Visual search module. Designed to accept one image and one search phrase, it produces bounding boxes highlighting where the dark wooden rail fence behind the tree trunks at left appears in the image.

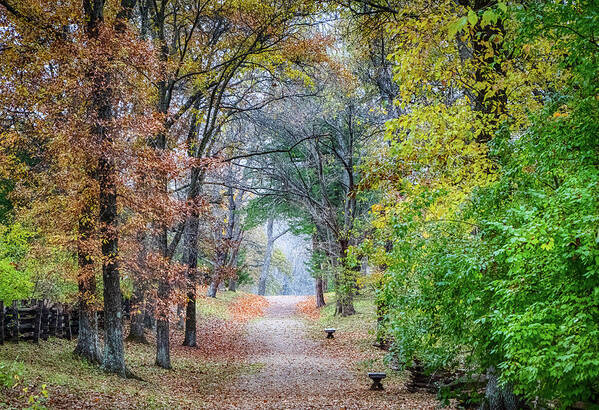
[0,299,130,345]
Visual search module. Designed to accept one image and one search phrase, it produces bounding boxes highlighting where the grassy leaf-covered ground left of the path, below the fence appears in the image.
[0,292,268,408]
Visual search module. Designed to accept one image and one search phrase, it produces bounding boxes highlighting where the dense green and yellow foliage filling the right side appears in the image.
[363,2,599,407]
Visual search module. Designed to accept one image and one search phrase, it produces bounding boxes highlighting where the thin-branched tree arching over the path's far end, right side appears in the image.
[234,65,380,315]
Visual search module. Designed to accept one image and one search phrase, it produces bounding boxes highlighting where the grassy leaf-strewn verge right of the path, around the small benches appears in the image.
[305,293,407,384]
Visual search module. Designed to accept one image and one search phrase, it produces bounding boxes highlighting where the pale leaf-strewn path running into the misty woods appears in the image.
[213,296,435,409]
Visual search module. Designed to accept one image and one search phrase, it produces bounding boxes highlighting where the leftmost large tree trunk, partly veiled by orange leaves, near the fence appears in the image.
[74,203,101,363]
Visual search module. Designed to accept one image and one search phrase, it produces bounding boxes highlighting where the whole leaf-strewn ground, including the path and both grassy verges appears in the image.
[0,292,446,409]
